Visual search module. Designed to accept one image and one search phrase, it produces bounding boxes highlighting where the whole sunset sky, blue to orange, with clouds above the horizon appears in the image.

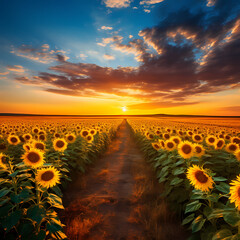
[0,0,240,116]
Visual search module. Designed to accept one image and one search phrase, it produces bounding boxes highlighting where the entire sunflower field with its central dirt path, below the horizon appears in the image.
[0,116,240,240]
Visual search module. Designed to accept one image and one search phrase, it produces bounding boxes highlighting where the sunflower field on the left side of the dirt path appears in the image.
[0,118,121,240]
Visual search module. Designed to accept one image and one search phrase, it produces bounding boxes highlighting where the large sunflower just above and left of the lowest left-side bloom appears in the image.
[22,148,44,168]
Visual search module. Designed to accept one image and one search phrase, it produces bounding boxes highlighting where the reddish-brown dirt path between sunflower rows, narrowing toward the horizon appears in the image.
[61,120,188,240]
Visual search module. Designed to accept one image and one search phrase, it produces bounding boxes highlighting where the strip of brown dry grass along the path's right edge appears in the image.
[129,158,187,240]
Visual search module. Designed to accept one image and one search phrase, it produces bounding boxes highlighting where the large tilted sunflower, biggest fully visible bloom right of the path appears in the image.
[187,165,214,192]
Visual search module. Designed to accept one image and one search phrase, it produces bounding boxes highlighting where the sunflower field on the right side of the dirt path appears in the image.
[129,119,240,240]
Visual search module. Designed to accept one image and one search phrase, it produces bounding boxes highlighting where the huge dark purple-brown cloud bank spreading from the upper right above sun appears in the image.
[14,0,240,108]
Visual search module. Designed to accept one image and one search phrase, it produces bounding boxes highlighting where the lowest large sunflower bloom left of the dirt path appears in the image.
[36,167,60,188]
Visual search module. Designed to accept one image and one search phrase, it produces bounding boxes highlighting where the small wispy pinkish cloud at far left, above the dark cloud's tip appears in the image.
[11,44,69,64]
